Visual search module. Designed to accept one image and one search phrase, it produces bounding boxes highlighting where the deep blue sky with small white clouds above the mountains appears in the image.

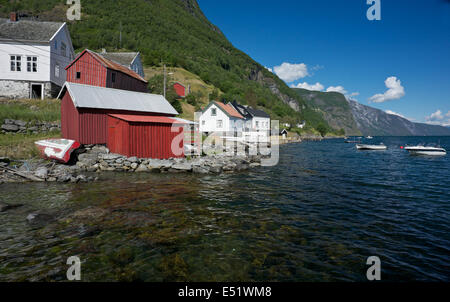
[198,0,450,125]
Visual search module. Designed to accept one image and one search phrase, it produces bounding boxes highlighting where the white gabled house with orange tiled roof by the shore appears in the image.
[199,102,244,134]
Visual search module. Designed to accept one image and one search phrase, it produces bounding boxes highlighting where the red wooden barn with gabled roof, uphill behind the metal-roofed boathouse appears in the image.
[65,49,148,92]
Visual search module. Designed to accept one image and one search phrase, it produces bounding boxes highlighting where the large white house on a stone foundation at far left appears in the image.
[0,13,74,99]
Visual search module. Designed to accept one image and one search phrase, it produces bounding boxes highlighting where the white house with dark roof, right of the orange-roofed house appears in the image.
[231,101,270,142]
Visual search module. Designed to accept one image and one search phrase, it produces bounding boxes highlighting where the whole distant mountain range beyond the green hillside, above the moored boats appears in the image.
[292,88,450,136]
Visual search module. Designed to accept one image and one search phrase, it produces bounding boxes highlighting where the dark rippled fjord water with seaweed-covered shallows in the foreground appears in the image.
[0,137,450,281]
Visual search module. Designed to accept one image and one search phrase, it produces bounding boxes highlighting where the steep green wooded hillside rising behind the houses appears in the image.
[0,0,326,131]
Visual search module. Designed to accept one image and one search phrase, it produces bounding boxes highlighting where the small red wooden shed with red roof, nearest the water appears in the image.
[107,114,184,159]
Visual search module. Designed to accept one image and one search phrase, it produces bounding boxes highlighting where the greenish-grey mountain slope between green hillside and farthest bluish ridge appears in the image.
[293,88,361,135]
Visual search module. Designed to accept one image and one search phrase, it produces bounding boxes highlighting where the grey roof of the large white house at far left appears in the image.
[0,18,64,42]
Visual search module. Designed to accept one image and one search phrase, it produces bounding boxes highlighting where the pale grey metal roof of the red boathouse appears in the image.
[58,82,178,115]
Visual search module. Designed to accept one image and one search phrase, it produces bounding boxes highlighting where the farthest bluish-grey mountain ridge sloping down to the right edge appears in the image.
[349,101,450,136]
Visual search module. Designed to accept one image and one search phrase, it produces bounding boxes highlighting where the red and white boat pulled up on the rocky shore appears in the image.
[35,138,81,163]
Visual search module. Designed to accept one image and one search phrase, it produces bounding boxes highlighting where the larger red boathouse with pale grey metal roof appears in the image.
[58,82,178,145]
